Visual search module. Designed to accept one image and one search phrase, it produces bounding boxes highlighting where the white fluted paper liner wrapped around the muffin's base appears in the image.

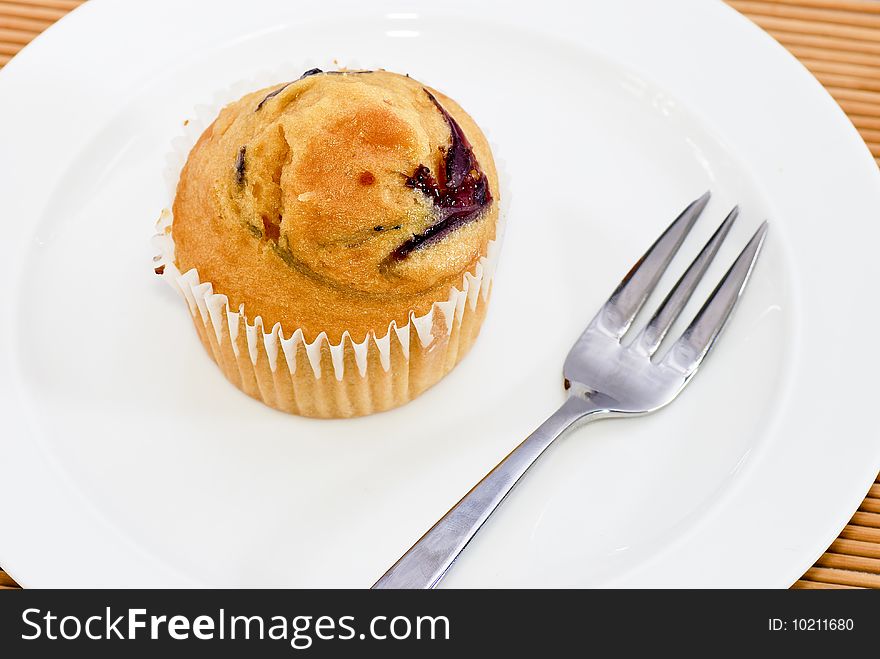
[153,65,502,418]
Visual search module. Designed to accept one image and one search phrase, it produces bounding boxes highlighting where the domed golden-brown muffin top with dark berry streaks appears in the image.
[172,69,499,342]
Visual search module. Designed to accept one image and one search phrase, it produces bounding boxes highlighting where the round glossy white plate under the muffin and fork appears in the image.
[0,0,880,587]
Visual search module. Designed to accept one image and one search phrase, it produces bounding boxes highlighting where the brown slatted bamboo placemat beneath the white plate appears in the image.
[0,0,880,590]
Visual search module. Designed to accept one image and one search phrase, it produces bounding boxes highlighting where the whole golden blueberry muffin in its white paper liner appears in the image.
[157,69,500,417]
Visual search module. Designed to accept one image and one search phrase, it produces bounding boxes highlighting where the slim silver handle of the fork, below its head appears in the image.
[373,395,602,588]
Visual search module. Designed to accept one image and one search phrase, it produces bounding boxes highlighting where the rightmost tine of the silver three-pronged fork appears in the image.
[663,222,768,375]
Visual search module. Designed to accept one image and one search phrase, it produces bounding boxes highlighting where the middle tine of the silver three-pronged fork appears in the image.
[633,206,739,355]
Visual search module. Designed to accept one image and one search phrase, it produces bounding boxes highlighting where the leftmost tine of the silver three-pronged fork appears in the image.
[593,191,710,338]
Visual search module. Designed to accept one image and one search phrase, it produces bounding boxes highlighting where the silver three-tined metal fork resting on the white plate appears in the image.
[373,192,768,588]
